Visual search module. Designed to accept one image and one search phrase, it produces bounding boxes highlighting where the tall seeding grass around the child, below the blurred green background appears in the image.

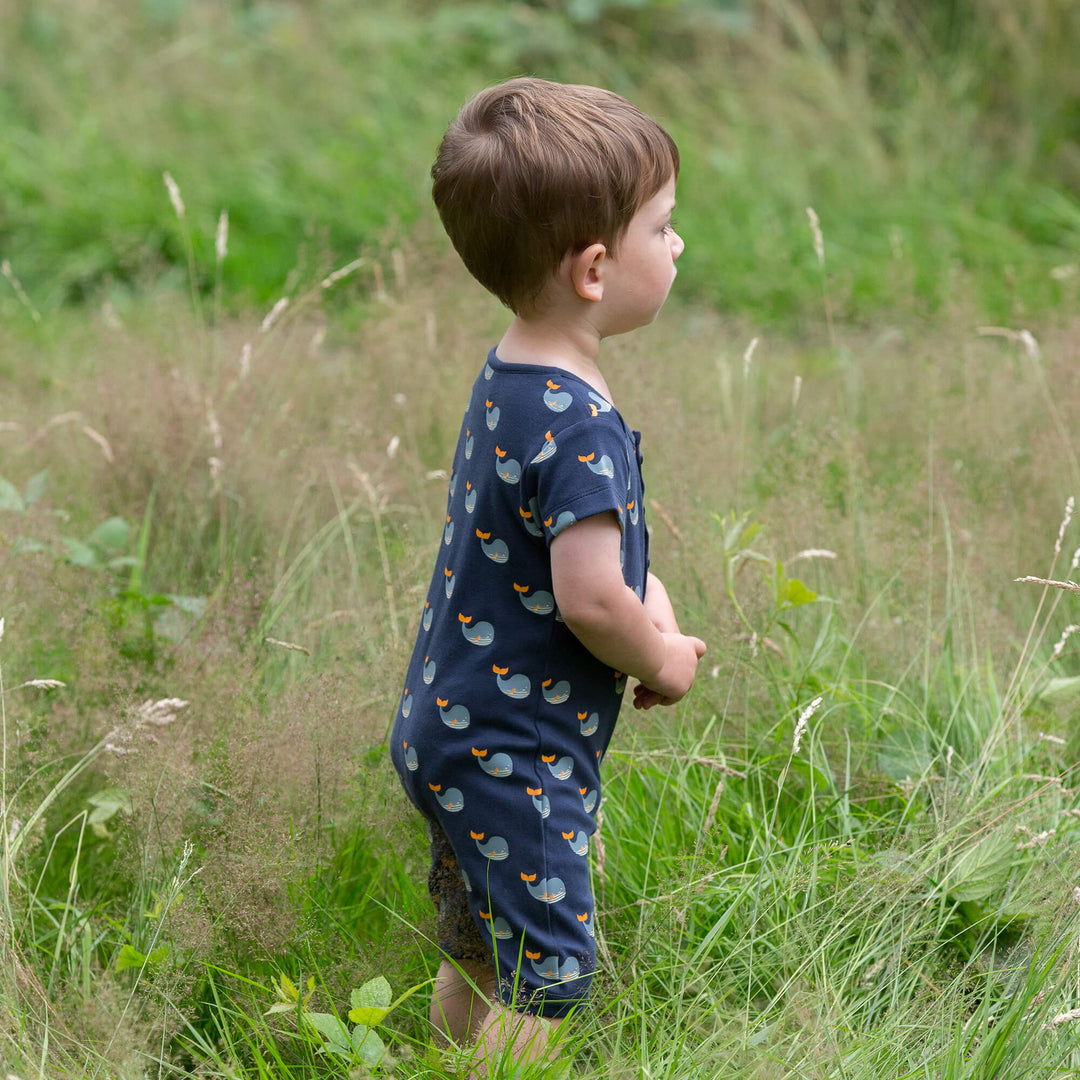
[0,192,1080,1078]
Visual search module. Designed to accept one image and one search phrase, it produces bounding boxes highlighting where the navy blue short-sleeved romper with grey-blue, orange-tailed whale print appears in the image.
[391,349,648,1017]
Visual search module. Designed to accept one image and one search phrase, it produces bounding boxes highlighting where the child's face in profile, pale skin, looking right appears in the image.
[603,177,684,334]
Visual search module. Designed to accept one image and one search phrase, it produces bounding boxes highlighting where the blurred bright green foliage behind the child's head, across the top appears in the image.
[0,0,1080,320]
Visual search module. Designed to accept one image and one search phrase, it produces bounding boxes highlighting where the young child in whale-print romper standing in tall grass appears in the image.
[391,79,705,1071]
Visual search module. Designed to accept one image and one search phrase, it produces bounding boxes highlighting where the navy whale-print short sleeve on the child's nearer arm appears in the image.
[523,414,635,543]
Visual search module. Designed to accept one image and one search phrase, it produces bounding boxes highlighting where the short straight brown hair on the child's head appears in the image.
[431,79,678,312]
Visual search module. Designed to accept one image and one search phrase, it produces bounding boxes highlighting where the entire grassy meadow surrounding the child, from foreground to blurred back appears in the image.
[0,0,1080,1080]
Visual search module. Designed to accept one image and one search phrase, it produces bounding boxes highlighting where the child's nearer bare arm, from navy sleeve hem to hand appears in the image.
[551,513,705,702]
